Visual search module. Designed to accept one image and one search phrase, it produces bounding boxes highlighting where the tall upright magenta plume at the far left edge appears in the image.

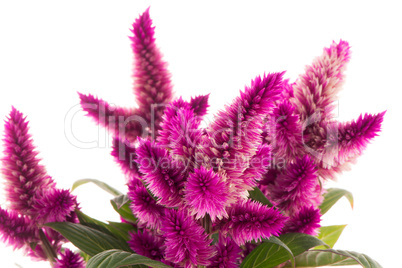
[1,107,54,215]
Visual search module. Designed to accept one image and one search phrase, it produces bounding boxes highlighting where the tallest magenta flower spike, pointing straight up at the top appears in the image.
[130,8,172,133]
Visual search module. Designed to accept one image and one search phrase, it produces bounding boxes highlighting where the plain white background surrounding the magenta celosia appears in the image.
[0,0,402,268]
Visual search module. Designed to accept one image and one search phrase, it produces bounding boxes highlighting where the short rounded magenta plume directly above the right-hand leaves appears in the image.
[271,155,321,215]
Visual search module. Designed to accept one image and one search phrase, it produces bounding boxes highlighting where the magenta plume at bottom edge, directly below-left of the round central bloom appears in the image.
[162,210,216,267]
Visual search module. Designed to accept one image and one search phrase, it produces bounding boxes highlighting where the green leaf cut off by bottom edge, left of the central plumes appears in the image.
[86,249,171,268]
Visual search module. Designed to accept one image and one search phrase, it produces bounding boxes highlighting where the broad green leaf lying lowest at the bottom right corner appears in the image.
[286,249,382,268]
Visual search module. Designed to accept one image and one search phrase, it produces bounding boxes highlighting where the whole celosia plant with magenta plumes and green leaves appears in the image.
[0,6,385,268]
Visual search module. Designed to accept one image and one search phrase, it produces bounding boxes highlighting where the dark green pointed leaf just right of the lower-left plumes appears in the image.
[45,222,131,256]
